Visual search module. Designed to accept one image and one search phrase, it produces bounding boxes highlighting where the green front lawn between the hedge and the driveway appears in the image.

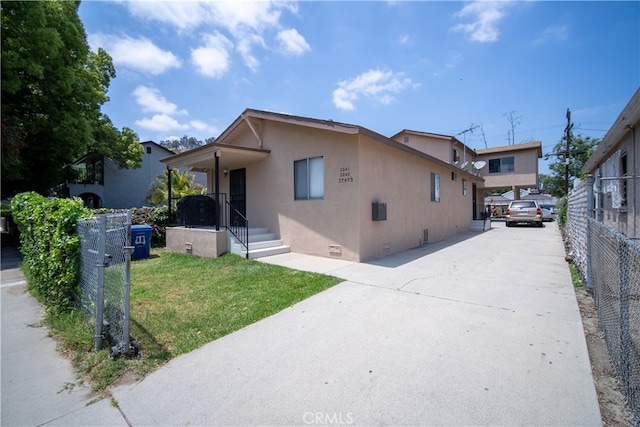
[48,251,342,391]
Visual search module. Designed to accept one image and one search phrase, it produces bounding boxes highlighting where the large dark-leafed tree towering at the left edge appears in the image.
[1,0,142,195]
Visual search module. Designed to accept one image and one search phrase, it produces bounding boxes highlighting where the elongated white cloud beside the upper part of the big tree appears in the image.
[88,34,182,75]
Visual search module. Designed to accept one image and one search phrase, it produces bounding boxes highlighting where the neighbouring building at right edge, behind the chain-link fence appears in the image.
[582,88,640,239]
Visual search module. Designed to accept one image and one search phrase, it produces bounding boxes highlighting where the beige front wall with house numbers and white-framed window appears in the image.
[241,121,359,261]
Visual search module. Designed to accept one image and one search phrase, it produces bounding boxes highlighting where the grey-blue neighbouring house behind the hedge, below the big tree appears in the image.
[61,141,206,209]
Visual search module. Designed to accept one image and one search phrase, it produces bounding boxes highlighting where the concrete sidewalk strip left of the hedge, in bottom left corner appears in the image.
[0,247,127,426]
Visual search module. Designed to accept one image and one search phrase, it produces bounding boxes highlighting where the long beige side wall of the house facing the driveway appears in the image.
[358,137,473,260]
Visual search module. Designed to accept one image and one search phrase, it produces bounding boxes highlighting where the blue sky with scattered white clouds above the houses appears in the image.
[79,0,640,173]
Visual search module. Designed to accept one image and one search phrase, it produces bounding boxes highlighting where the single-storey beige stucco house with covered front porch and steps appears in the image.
[163,109,484,261]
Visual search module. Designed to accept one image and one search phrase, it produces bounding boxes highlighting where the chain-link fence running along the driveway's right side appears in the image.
[565,180,640,425]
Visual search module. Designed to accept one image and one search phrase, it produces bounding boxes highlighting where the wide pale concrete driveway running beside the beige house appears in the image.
[113,223,601,426]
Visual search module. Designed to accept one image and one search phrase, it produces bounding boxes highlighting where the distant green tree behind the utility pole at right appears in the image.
[540,134,600,197]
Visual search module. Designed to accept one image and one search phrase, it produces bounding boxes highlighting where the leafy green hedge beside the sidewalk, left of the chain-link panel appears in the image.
[11,192,92,312]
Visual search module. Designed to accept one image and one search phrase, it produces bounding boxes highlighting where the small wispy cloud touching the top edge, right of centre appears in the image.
[451,0,509,43]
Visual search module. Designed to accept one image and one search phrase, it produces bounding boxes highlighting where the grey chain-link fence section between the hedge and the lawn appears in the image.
[77,212,138,357]
